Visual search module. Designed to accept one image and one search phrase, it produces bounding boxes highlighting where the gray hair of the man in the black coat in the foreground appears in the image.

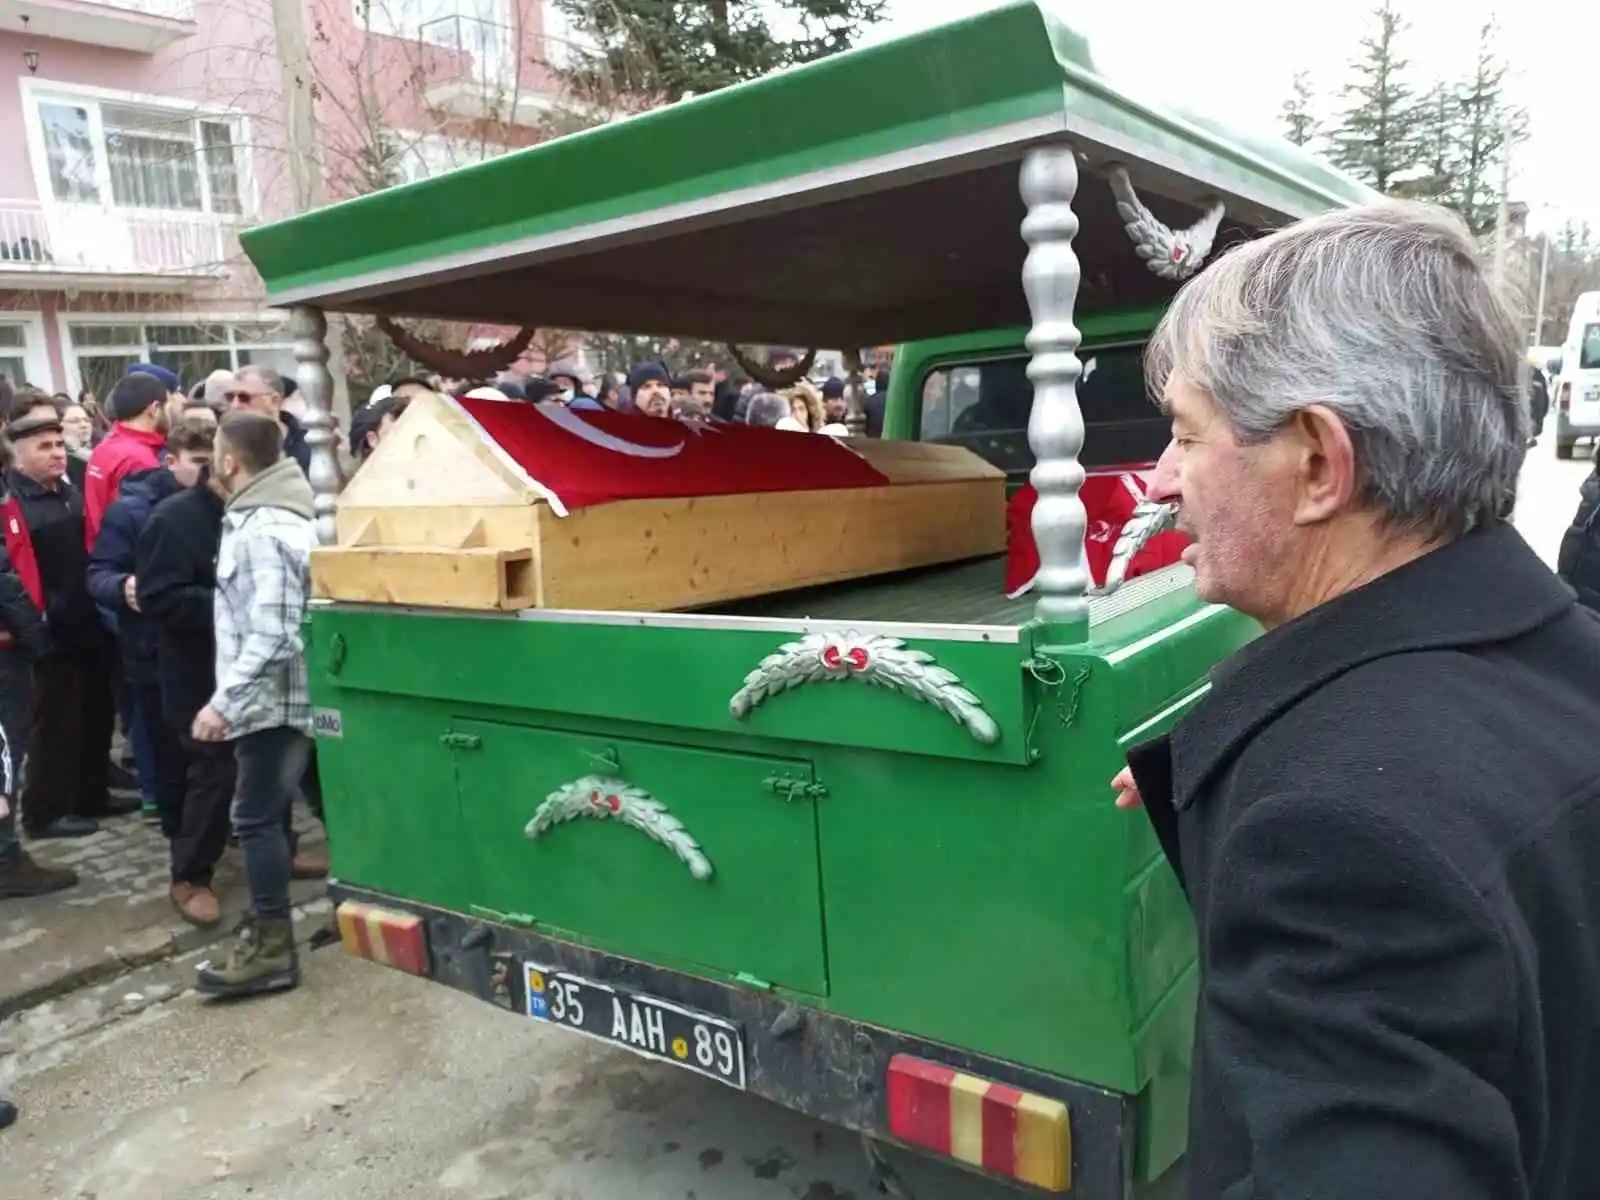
[1146,202,1530,538]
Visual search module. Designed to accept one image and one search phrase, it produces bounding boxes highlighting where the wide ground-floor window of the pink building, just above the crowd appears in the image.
[69,318,294,398]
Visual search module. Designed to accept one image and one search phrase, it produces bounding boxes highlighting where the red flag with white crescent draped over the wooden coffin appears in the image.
[454,398,890,510]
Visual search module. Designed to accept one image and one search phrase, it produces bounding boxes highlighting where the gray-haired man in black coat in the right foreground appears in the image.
[1112,203,1600,1200]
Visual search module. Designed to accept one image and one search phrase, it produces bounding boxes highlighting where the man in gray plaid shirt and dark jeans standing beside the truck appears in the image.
[194,411,315,997]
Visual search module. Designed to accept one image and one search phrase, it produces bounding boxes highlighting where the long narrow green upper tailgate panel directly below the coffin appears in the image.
[309,606,1030,763]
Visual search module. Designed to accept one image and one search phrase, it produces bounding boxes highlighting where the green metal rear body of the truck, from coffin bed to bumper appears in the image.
[312,597,1237,1126]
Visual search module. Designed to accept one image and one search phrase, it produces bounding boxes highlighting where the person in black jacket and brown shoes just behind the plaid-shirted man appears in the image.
[134,451,234,926]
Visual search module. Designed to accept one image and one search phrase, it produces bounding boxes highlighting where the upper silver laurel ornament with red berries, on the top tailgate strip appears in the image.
[728,632,1000,746]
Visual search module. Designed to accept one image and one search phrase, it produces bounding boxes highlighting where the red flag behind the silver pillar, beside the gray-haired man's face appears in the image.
[1005,462,1189,597]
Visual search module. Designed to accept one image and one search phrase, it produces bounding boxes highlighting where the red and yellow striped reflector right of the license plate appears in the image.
[888,1054,1072,1192]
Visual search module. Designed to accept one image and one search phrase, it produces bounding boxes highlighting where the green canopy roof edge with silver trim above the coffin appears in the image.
[242,0,1373,302]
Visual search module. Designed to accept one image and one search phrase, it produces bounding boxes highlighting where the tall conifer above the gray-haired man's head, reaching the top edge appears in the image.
[1331,0,1421,192]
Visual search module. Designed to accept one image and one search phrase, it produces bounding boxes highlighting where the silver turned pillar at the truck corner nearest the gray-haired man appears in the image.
[1021,144,1090,626]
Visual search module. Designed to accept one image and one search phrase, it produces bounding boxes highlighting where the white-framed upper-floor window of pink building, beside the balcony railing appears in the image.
[38,98,243,214]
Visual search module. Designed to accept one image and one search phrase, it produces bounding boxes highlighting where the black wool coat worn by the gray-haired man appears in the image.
[1130,525,1600,1200]
